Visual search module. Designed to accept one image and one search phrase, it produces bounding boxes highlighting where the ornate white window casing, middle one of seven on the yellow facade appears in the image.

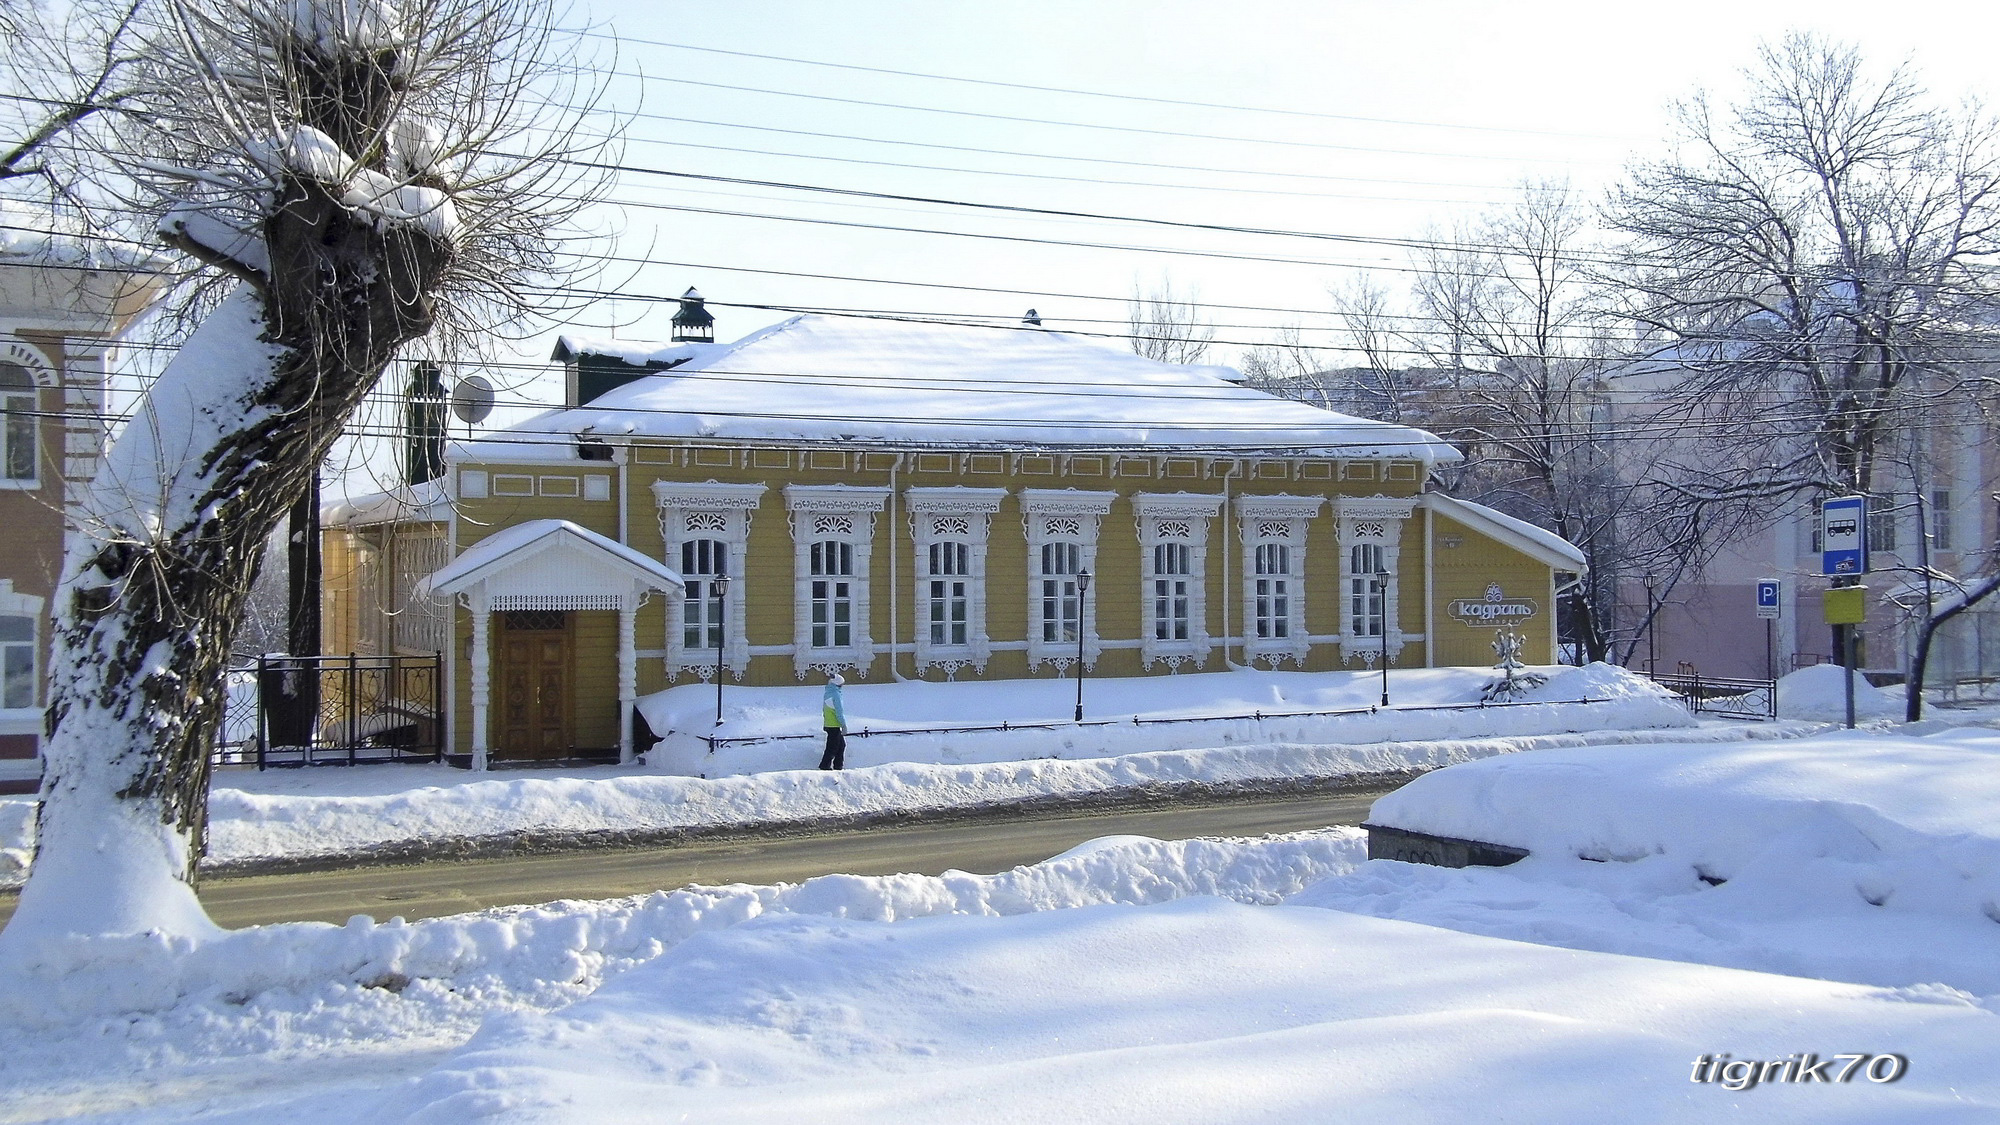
[1020,488,1118,673]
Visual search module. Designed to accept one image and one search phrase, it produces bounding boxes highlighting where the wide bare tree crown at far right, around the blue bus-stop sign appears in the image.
[1610,34,2000,498]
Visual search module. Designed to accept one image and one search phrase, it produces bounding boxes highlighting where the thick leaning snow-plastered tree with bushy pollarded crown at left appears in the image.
[4,0,592,941]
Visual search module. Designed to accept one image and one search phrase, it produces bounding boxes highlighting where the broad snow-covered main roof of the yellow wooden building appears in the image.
[516,314,1460,464]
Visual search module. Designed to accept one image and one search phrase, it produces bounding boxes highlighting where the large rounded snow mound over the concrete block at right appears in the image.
[1328,729,2000,984]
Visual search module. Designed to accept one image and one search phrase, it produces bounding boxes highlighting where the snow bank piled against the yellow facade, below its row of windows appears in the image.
[638,665,1694,777]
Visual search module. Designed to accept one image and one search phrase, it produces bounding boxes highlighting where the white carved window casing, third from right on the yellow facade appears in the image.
[1132,492,1222,669]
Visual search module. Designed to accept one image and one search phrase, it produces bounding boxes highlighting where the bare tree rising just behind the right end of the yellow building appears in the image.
[1412,184,1712,661]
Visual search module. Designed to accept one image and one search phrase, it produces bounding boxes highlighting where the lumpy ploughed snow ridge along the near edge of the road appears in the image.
[0,829,1360,1032]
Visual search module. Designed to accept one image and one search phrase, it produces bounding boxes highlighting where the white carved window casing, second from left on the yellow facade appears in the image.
[784,484,888,679]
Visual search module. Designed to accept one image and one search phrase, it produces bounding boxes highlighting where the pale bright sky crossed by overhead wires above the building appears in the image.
[320,0,2000,476]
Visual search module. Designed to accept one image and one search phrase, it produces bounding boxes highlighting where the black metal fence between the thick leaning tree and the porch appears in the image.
[216,655,444,769]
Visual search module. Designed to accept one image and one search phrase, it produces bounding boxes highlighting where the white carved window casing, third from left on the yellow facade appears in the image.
[902,488,1006,677]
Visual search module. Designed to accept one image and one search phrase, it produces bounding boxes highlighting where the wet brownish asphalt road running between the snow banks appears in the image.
[0,789,1386,927]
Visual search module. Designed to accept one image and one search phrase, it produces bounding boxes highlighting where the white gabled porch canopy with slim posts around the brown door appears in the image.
[422,520,684,769]
